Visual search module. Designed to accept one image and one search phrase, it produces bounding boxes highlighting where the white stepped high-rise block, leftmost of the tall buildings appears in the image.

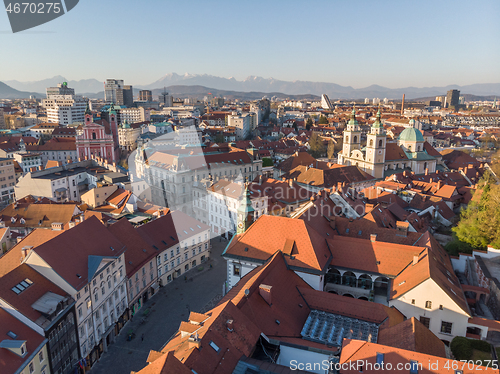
[42,82,87,125]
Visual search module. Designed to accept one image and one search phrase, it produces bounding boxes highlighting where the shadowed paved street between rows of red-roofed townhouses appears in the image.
[88,238,228,374]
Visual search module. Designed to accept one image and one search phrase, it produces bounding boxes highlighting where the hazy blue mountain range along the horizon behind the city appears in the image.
[0,73,500,100]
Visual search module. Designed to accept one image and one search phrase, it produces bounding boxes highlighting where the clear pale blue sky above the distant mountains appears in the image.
[0,0,500,88]
